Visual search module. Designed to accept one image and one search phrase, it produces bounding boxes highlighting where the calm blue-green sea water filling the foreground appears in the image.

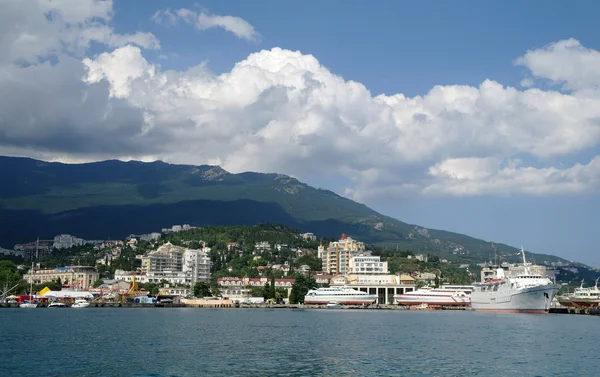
[0,308,600,377]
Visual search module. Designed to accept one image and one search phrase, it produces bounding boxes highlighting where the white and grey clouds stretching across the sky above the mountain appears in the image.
[0,0,600,201]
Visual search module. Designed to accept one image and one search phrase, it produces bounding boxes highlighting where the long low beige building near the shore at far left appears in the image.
[23,266,100,289]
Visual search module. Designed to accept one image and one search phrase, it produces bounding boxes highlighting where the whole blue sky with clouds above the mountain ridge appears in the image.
[0,0,600,267]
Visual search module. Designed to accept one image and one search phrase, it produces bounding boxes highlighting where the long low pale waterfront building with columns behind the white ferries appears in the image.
[330,274,415,304]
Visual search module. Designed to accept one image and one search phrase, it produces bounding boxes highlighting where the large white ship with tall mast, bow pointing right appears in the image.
[471,248,560,313]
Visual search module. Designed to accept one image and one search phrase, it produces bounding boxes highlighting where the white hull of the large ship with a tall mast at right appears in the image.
[471,284,560,313]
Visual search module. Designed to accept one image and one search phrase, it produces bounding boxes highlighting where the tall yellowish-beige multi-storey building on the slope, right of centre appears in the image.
[318,234,366,275]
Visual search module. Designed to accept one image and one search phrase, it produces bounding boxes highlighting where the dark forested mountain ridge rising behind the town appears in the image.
[0,157,568,263]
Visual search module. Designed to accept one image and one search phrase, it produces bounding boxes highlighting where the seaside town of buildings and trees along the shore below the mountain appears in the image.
[0,224,598,311]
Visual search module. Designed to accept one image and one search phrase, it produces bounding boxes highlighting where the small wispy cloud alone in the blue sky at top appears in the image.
[152,8,260,42]
